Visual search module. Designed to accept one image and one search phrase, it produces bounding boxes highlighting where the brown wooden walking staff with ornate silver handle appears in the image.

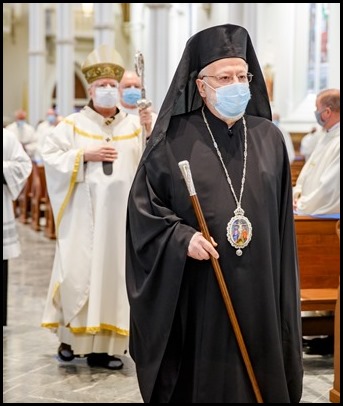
[179,161,263,403]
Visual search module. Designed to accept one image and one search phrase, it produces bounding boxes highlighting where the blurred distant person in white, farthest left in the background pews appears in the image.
[6,109,37,159]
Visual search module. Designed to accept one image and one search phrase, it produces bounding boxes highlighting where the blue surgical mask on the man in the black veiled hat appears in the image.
[205,82,251,119]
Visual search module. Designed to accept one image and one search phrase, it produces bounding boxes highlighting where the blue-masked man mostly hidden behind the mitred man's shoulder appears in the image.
[119,71,157,138]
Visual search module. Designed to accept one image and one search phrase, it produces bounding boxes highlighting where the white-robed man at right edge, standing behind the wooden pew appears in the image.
[293,89,340,215]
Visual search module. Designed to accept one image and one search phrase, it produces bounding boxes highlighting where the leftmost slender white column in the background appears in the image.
[28,3,49,126]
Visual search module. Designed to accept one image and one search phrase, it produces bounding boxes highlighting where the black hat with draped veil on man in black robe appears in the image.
[145,24,271,155]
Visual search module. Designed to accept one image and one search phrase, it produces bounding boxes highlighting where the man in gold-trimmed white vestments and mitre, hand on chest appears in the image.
[41,45,142,370]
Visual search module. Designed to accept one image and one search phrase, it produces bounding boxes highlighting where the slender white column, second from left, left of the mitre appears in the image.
[56,3,75,116]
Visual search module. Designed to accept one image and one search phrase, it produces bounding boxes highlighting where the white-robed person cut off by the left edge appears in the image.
[2,128,32,326]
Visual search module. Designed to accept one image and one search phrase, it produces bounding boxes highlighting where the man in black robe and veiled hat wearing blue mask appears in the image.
[126,24,303,403]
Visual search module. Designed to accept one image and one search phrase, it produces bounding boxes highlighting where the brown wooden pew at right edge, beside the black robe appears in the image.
[294,215,340,336]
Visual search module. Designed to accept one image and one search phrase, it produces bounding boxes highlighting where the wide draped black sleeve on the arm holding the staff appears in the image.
[126,144,196,401]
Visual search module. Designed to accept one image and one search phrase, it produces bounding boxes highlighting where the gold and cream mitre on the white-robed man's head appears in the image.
[81,45,125,83]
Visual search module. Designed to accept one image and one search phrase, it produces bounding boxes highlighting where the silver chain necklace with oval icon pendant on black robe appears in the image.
[201,106,252,256]
